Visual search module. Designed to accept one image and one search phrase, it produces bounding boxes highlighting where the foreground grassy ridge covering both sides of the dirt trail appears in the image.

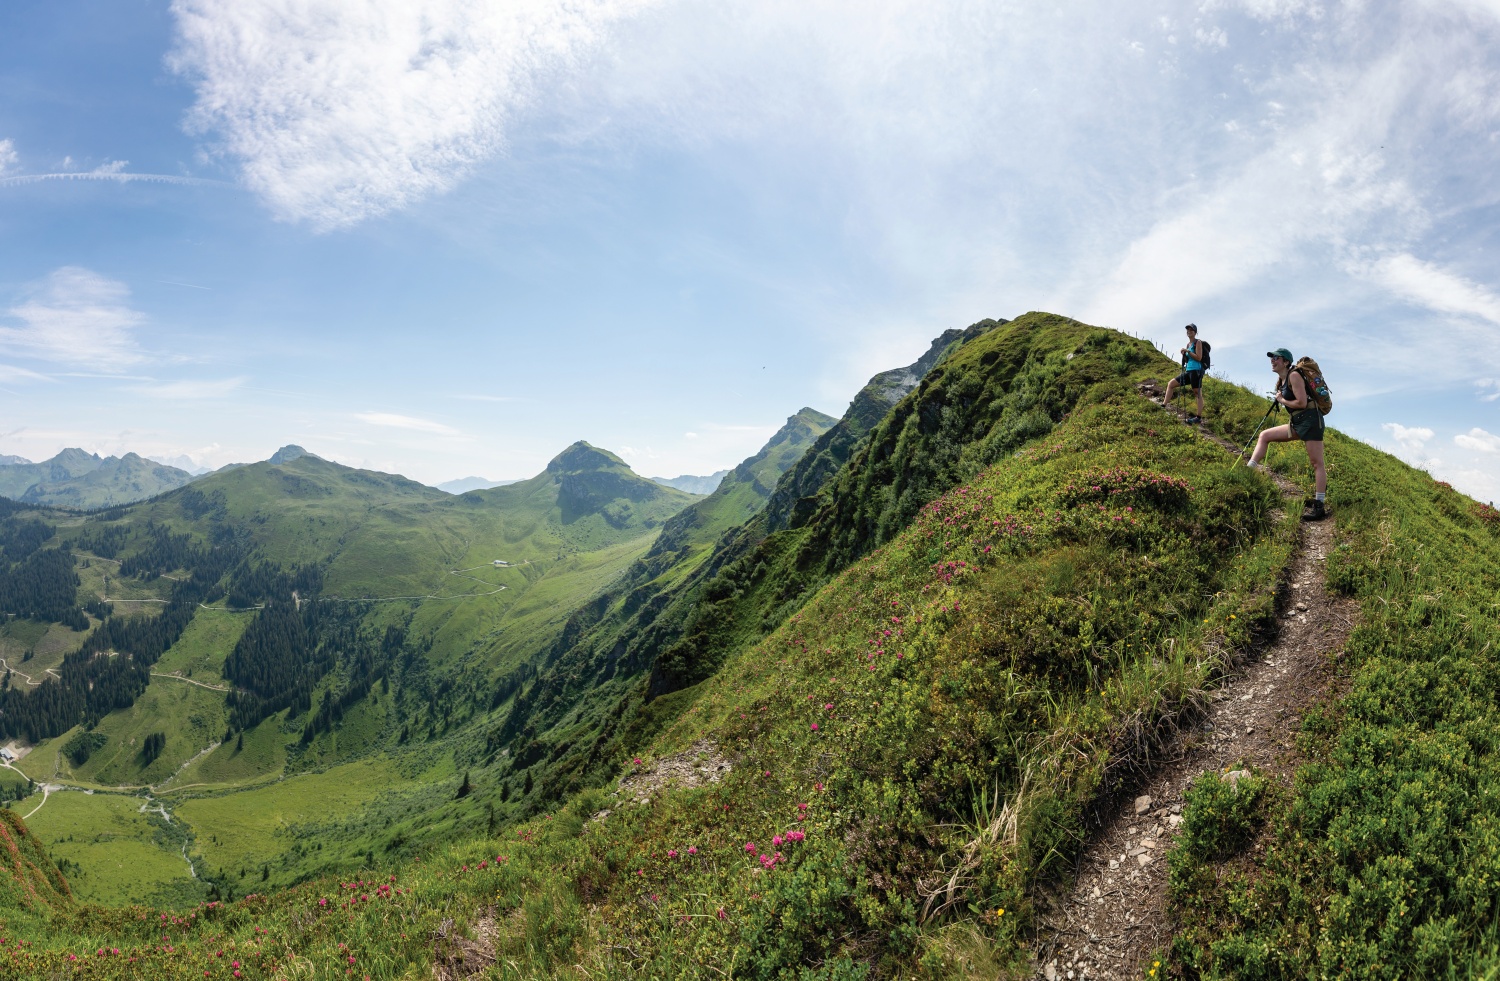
[17,315,1500,978]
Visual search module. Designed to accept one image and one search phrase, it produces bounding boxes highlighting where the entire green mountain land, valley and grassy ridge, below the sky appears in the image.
[0,312,1500,980]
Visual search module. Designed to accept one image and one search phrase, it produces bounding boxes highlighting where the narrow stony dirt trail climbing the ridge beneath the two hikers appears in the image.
[1037,386,1359,981]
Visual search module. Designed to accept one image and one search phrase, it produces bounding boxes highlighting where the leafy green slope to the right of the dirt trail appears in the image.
[1175,434,1500,978]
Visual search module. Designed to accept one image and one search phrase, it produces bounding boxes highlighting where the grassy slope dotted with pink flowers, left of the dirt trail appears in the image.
[0,334,1314,978]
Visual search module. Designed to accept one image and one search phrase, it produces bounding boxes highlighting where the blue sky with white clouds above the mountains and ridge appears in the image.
[0,0,1500,500]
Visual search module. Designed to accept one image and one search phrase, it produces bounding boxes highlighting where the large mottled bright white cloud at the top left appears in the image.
[170,0,656,230]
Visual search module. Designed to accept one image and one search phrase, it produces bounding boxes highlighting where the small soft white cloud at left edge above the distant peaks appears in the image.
[0,266,146,374]
